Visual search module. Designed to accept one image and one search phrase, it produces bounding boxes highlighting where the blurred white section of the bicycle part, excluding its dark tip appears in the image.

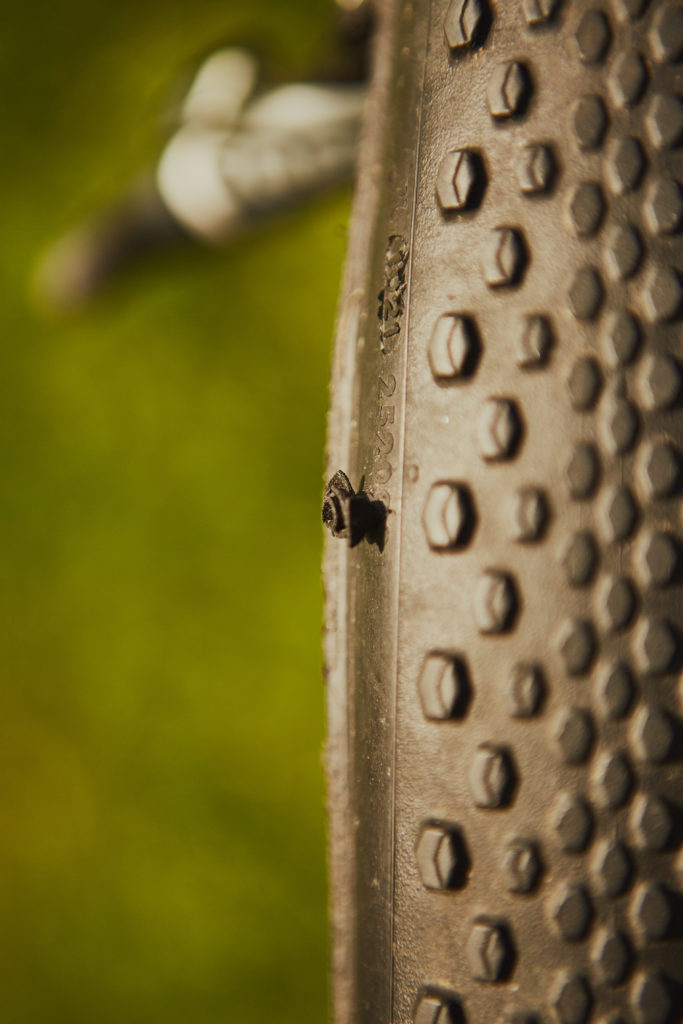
[157,49,366,243]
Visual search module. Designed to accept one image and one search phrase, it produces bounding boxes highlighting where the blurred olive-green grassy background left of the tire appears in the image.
[0,0,348,1024]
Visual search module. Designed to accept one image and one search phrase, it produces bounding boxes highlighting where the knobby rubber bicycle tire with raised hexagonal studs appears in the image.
[326,0,683,1024]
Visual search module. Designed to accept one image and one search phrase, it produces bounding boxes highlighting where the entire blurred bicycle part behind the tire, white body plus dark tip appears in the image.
[36,0,373,308]
